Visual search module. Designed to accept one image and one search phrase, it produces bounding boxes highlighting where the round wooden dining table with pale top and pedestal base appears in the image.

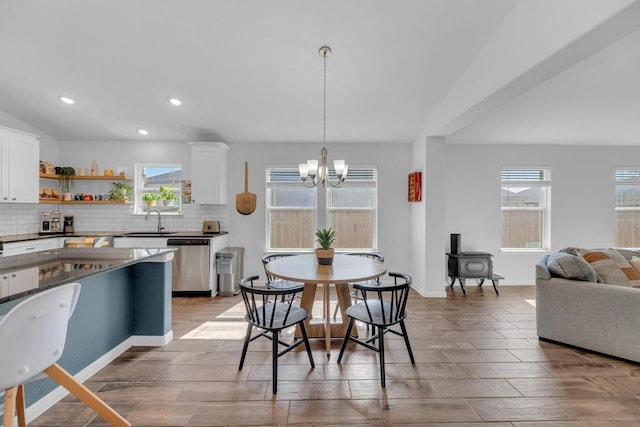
[265,254,387,356]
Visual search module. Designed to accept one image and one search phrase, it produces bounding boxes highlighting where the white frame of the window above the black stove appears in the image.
[500,166,551,252]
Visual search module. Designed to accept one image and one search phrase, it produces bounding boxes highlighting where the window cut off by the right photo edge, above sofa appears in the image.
[615,168,640,248]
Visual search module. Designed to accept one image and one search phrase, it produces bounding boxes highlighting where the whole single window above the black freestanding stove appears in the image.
[500,167,551,250]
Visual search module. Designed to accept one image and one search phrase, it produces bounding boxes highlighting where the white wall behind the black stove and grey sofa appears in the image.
[443,144,640,284]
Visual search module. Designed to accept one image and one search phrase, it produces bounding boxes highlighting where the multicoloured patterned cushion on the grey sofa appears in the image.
[578,249,640,286]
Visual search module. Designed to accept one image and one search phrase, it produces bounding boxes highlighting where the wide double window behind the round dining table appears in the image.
[266,168,377,251]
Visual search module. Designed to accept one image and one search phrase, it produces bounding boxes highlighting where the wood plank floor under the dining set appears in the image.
[30,286,640,427]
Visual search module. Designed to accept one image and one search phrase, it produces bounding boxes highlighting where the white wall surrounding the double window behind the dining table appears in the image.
[229,143,412,277]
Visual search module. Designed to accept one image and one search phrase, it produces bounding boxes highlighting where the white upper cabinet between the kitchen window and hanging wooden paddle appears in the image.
[191,142,229,205]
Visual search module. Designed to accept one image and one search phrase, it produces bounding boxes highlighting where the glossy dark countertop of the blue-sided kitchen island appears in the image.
[0,248,176,304]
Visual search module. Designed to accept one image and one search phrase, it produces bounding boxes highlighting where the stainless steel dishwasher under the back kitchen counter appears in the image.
[167,238,211,296]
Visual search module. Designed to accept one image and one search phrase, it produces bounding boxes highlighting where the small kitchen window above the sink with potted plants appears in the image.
[133,163,182,215]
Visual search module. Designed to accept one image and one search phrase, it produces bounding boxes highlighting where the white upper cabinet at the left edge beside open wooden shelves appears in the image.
[0,127,40,203]
